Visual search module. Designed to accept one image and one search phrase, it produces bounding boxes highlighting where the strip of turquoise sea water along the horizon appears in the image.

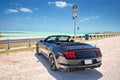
[0,31,86,37]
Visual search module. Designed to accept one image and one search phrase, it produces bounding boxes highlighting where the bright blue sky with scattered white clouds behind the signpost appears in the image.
[0,0,120,32]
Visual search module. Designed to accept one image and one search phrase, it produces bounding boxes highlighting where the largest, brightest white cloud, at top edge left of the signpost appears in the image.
[48,1,72,8]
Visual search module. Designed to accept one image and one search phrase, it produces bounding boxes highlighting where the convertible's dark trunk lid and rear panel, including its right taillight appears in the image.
[62,43,101,59]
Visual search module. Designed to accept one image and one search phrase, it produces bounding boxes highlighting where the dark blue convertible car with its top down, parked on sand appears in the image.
[36,35,102,71]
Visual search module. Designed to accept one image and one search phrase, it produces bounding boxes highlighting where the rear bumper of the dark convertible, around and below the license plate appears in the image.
[57,57,102,70]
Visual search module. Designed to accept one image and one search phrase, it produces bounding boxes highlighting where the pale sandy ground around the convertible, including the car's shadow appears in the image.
[0,37,120,80]
